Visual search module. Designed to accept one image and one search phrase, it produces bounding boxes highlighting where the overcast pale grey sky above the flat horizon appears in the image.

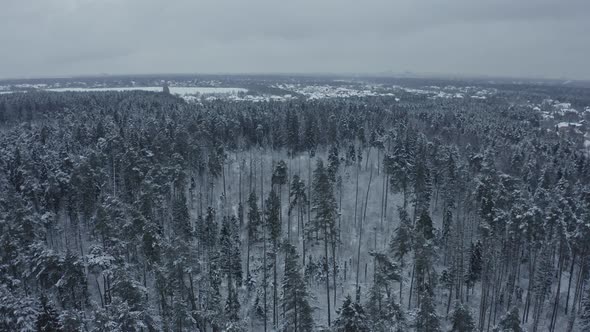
[0,0,590,79]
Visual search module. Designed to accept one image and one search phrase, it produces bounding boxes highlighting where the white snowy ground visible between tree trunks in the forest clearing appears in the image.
[209,150,584,331]
